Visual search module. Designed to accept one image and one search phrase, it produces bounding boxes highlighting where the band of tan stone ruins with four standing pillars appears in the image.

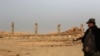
[0,22,84,45]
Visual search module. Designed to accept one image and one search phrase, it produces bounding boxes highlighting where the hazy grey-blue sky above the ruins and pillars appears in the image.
[0,0,100,33]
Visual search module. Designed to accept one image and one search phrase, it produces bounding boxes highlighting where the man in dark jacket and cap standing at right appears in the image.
[82,18,100,56]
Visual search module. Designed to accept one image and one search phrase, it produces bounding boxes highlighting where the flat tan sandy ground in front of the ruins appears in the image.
[0,38,83,56]
